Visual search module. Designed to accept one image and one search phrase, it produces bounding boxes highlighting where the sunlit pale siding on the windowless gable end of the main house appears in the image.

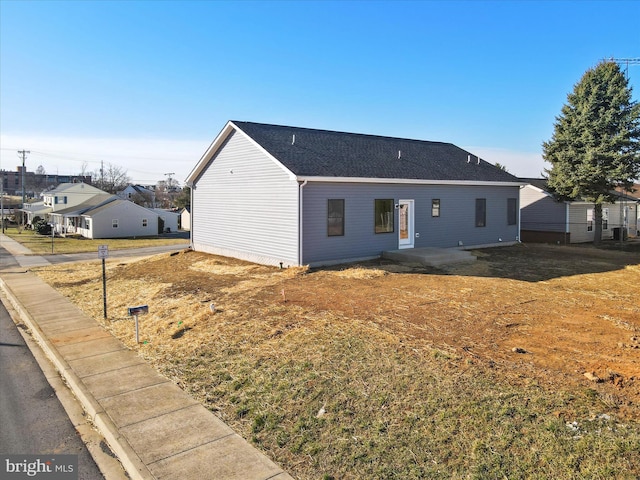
[191,133,299,265]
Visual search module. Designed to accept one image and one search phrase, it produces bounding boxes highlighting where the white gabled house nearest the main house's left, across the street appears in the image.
[79,197,159,238]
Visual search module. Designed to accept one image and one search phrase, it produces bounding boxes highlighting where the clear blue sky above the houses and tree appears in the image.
[0,0,640,185]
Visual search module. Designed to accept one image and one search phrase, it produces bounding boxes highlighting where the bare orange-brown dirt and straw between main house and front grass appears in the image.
[42,245,640,418]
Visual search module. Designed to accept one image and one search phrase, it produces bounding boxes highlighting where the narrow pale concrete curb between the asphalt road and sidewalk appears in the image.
[0,272,155,480]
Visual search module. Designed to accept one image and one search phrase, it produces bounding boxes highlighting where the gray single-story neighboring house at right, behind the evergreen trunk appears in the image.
[520,178,639,244]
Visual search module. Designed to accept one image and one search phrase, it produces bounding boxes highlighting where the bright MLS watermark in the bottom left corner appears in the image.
[0,455,78,480]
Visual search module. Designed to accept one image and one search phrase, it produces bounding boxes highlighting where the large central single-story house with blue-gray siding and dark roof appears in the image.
[187,121,522,266]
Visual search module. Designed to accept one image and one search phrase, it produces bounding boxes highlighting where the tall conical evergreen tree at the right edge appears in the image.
[542,61,640,244]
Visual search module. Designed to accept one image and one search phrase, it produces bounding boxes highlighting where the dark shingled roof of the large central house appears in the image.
[232,121,519,182]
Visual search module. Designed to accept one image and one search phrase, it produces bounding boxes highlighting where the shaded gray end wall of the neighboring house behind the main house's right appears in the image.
[520,185,567,233]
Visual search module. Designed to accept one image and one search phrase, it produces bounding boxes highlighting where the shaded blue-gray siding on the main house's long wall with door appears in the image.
[302,182,519,264]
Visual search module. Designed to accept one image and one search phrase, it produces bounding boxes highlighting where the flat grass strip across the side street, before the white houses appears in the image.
[5,228,188,255]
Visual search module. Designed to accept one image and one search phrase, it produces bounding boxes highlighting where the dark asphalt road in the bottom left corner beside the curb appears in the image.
[0,298,104,480]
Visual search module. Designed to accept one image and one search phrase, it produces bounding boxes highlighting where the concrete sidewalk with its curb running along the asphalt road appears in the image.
[0,235,292,480]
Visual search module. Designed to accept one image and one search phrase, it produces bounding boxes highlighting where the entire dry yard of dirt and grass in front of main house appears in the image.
[37,245,640,479]
